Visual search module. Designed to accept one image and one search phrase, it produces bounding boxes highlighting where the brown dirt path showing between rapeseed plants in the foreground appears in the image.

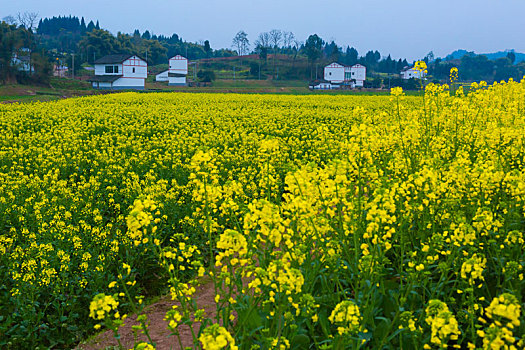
[76,280,216,350]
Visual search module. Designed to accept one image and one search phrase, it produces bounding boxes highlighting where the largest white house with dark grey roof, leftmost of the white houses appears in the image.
[88,54,148,90]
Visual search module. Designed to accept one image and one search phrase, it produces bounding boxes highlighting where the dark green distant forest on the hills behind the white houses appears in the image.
[0,14,525,86]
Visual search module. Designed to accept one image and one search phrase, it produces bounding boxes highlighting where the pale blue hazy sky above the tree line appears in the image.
[0,0,525,60]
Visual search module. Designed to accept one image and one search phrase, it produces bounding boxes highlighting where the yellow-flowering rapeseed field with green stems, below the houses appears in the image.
[0,78,525,349]
